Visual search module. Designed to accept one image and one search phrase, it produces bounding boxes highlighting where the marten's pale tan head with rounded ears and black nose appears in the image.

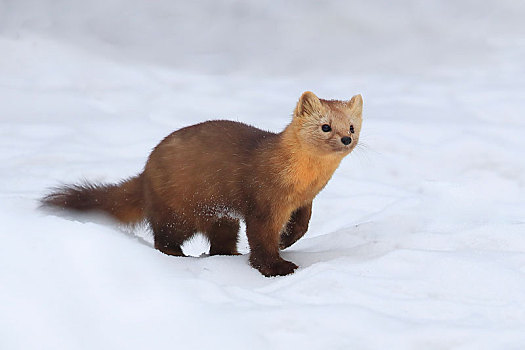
[290,91,363,156]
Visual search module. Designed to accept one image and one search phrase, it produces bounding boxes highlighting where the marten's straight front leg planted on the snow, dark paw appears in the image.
[246,214,297,277]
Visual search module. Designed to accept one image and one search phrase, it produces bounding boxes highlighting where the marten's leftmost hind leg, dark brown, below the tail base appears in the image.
[148,214,196,256]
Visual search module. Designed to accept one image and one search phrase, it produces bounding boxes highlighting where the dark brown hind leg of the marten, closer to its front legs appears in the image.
[205,218,240,255]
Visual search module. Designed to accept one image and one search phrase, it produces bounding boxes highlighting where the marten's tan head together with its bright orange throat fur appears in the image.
[279,91,363,202]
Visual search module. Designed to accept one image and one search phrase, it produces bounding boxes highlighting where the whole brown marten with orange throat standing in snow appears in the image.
[42,92,363,276]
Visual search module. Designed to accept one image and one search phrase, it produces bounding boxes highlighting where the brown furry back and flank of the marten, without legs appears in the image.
[143,120,279,228]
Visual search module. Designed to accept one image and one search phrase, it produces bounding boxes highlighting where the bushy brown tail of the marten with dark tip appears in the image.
[41,175,144,224]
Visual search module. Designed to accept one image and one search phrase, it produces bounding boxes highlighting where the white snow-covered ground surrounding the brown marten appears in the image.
[0,0,525,349]
